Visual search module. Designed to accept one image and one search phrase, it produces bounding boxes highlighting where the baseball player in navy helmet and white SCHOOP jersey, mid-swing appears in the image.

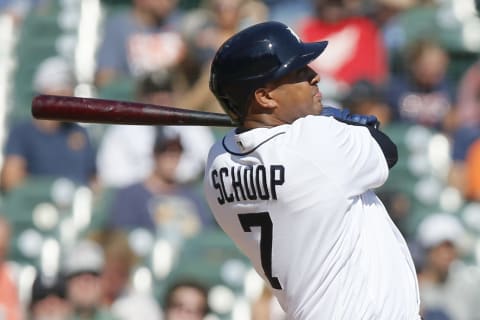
[204,21,420,320]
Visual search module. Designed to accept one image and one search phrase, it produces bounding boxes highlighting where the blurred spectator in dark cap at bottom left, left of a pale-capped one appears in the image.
[27,272,72,320]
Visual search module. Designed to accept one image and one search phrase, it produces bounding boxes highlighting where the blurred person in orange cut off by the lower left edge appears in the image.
[0,214,23,320]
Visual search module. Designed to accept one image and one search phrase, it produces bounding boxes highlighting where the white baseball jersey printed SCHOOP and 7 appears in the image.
[204,116,419,320]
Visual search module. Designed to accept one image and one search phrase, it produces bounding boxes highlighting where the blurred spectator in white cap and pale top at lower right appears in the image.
[417,213,480,320]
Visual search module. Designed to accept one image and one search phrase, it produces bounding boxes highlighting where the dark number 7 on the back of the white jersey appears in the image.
[238,212,282,290]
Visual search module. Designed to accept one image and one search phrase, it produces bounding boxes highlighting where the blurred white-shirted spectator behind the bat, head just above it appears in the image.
[97,70,214,188]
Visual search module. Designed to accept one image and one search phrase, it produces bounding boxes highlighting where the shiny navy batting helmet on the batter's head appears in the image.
[210,21,327,123]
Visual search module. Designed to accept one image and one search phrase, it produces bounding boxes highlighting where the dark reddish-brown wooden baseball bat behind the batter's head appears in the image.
[32,94,236,127]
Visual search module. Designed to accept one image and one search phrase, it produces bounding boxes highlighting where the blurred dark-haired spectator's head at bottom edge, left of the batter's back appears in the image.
[163,280,209,320]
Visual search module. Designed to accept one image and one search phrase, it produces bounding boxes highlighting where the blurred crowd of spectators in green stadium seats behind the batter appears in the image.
[0,0,480,320]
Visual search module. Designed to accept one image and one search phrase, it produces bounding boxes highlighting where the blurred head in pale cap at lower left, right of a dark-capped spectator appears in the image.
[64,240,114,320]
